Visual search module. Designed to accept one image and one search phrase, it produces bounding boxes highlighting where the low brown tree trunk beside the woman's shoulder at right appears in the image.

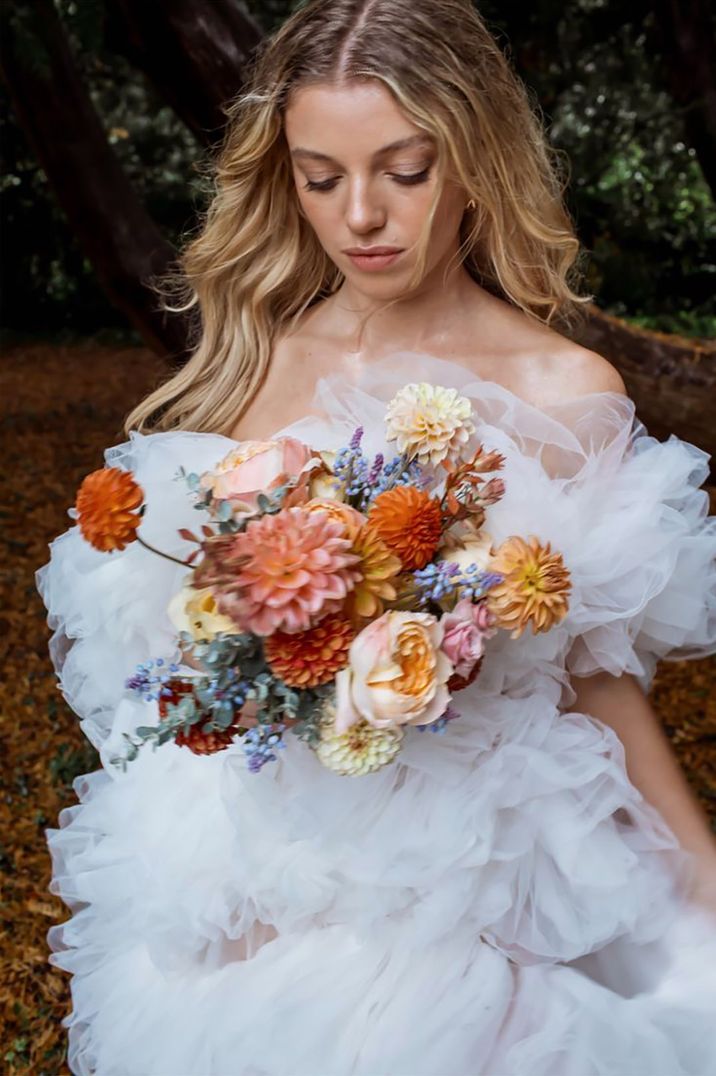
[577,306,716,471]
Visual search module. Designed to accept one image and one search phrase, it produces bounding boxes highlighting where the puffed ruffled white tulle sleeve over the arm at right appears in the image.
[546,399,716,691]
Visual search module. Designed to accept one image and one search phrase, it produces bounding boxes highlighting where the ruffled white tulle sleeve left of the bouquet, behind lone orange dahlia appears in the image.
[36,431,235,748]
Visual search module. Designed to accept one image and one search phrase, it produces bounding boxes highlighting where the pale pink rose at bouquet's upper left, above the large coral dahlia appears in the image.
[200,437,313,509]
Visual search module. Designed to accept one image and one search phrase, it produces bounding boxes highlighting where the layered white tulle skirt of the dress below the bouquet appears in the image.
[48,686,716,1076]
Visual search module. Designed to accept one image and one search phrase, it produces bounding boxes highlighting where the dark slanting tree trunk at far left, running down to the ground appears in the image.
[0,0,188,360]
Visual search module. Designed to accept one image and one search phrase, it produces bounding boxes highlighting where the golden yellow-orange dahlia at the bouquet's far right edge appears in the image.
[487,535,572,639]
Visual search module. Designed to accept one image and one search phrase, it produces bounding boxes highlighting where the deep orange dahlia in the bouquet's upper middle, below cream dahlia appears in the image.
[368,485,443,571]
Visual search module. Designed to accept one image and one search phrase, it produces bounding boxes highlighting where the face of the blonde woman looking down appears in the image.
[285,80,465,300]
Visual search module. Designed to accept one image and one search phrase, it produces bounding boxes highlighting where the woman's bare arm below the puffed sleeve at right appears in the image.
[570,673,716,914]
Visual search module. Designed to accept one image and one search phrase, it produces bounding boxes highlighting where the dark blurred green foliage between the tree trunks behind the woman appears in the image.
[0,0,716,341]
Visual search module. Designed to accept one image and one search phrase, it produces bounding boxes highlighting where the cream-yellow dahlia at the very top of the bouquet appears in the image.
[385,382,475,465]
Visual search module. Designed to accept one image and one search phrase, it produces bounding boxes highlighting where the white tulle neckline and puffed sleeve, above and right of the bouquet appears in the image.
[277,353,716,690]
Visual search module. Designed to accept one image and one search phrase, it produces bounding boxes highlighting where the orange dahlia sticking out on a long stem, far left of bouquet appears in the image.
[74,467,144,553]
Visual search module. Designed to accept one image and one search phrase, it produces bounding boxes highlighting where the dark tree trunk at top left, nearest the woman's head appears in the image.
[107,0,262,144]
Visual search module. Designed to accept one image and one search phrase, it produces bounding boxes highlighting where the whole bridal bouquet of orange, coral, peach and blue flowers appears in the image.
[74,384,570,775]
